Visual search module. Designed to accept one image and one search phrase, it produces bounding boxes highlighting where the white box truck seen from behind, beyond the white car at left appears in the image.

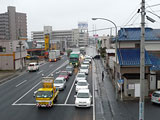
[49,50,61,62]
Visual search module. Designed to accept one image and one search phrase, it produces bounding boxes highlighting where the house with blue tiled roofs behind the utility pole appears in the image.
[107,27,160,97]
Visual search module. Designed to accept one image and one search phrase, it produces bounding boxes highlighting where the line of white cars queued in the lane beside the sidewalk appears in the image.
[74,56,92,107]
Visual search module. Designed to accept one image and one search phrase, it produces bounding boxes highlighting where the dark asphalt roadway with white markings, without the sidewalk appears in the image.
[0,56,94,120]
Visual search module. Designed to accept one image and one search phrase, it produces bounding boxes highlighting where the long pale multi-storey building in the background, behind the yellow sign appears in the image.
[31,26,88,51]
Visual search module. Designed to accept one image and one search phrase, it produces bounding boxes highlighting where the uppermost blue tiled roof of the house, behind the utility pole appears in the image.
[118,28,160,41]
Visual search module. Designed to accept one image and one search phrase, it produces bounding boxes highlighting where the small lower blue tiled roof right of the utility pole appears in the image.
[149,54,160,71]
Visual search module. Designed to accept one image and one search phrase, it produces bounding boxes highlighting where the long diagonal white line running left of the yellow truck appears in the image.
[12,61,68,105]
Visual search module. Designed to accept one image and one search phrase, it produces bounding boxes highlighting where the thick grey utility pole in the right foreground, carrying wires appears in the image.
[139,0,146,120]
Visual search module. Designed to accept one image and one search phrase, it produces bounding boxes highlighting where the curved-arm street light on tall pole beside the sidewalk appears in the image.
[92,18,118,99]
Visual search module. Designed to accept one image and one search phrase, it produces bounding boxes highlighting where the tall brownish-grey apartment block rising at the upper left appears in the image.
[0,6,27,40]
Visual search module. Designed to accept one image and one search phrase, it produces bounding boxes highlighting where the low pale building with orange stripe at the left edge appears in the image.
[0,40,27,70]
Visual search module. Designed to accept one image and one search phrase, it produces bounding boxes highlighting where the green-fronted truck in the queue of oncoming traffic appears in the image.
[69,52,80,67]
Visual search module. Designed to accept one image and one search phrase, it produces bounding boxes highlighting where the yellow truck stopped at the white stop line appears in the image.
[35,77,59,107]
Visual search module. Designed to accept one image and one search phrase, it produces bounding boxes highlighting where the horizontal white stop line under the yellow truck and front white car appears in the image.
[13,103,93,107]
